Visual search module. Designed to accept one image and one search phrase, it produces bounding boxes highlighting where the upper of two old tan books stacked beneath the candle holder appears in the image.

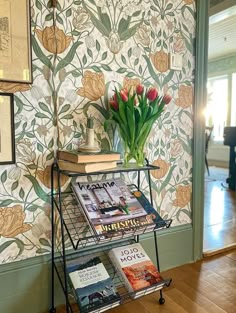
[57,150,120,163]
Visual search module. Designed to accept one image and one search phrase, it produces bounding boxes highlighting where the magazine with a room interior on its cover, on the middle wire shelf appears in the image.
[72,179,155,234]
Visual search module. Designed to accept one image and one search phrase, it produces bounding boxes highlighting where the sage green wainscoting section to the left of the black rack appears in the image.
[0,256,63,313]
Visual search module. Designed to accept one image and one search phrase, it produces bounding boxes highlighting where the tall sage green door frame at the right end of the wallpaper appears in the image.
[192,0,209,261]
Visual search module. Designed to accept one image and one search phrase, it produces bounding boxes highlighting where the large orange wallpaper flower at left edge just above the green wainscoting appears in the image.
[0,205,32,238]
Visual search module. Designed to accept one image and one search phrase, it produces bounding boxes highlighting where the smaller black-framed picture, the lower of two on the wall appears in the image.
[0,93,15,165]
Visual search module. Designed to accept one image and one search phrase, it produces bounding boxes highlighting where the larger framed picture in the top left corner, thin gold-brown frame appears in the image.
[0,0,32,83]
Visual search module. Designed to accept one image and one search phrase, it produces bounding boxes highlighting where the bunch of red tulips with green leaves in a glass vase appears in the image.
[106,85,171,165]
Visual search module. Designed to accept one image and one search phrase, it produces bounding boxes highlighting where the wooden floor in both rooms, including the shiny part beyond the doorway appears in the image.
[53,168,236,313]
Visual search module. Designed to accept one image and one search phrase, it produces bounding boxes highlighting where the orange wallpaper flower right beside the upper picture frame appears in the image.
[35,26,72,54]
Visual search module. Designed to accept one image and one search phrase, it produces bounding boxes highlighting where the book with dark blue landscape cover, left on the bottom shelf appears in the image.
[66,257,120,313]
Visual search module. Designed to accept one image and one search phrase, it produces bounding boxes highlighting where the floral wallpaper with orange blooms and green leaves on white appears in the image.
[0,0,196,263]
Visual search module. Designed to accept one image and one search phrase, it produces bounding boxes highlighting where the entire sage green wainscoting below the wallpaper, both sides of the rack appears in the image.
[0,225,193,313]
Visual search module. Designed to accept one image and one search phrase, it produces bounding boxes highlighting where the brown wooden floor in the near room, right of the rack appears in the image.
[54,250,236,313]
